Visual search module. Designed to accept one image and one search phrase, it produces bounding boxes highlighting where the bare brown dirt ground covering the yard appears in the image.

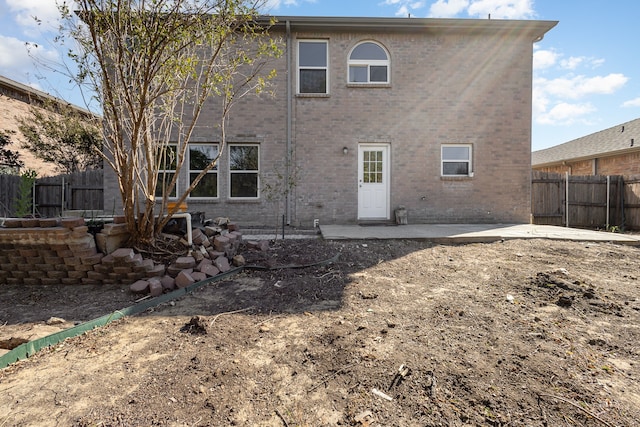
[0,240,640,427]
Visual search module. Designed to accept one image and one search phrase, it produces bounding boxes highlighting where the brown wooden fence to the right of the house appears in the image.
[531,171,624,229]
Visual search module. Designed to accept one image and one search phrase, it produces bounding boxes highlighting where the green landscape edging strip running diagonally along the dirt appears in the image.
[0,267,244,369]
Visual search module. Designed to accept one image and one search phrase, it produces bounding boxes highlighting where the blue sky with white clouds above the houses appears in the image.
[0,0,640,150]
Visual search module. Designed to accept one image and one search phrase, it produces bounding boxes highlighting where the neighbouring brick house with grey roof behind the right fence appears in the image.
[531,119,640,175]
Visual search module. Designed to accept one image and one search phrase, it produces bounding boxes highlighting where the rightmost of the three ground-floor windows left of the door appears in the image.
[229,144,260,199]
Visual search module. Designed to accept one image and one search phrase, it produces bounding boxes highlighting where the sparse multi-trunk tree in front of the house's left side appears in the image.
[60,0,281,244]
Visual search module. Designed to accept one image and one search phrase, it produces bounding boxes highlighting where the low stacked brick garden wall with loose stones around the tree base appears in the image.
[0,218,251,294]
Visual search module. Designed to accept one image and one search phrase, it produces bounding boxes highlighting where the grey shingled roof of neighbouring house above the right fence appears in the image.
[531,118,640,167]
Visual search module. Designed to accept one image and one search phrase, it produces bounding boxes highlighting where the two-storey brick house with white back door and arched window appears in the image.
[105,17,557,227]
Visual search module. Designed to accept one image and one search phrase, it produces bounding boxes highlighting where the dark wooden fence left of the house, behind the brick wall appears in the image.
[0,170,104,218]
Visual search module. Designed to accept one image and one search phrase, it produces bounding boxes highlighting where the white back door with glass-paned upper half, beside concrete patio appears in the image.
[358,142,391,220]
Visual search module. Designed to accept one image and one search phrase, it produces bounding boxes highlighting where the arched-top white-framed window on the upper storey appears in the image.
[348,41,390,84]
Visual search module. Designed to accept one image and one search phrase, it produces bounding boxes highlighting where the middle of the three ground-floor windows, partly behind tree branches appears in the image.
[189,144,219,199]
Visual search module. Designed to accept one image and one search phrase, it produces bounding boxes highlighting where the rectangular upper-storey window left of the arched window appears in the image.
[297,40,329,94]
